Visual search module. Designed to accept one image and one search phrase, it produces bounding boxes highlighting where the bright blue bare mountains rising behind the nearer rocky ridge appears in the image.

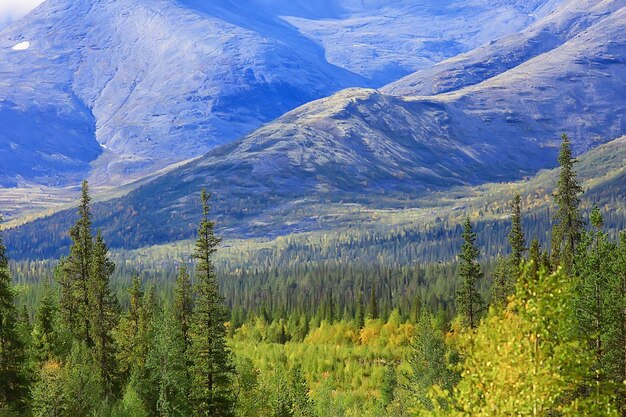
[0,0,554,187]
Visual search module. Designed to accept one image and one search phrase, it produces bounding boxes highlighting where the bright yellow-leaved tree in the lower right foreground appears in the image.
[417,268,618,417]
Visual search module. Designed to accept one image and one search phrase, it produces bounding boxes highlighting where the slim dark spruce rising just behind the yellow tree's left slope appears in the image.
[457,217,484,329]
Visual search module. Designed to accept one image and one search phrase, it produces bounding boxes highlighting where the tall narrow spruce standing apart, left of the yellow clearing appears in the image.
[190,189,234,417]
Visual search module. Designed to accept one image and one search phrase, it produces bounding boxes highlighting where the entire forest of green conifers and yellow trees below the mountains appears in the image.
[0,135,626,417]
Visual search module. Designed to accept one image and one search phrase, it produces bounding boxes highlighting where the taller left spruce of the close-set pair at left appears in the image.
[58,181,93,346]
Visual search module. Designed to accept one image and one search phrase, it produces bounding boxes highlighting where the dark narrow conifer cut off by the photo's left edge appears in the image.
[0,218,28,414]
